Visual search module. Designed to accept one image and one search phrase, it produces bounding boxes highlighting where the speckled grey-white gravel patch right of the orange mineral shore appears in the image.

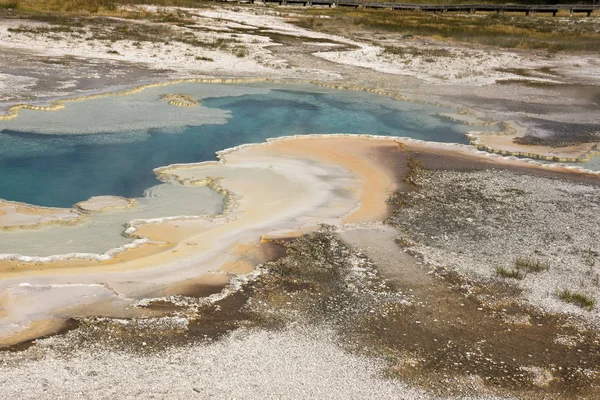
[388,170,600,326]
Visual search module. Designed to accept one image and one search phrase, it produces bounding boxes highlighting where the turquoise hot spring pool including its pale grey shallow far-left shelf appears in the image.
[0,83,488,207]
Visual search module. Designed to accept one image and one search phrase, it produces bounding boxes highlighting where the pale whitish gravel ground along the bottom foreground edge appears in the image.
[0,327,506,400]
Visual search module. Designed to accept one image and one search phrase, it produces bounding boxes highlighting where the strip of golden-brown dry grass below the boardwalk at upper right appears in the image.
[297,8,600,52]
